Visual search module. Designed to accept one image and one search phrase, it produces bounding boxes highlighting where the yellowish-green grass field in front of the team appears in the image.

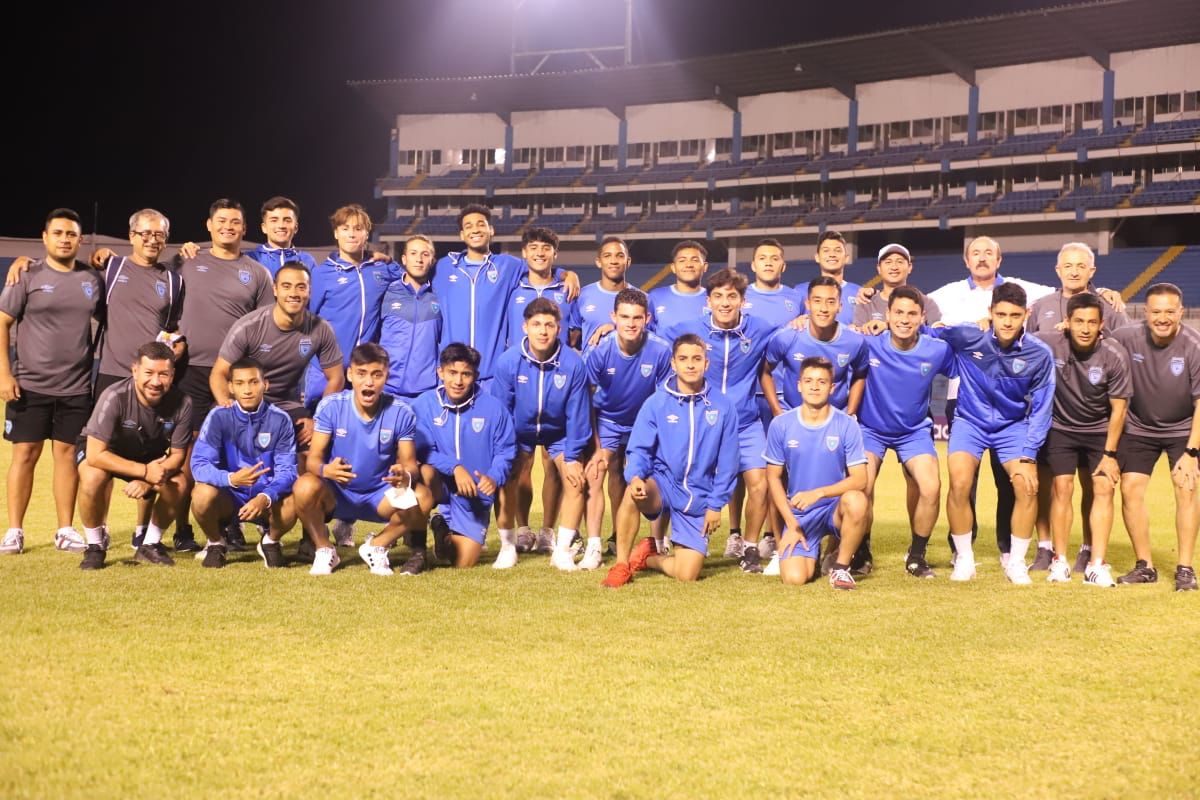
[0,447,1200,798]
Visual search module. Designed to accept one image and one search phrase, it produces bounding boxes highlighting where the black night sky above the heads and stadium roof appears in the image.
[7,0,1056,247]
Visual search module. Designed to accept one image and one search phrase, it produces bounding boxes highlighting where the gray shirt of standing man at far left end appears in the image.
[0,258,104,397]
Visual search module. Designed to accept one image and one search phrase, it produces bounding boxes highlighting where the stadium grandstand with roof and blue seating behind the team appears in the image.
[352,0,1200,300]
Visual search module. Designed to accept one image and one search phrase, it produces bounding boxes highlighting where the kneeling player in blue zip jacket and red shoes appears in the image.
[604,333,738,589]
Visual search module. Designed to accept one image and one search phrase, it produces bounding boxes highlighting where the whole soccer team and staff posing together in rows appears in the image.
[0,197,1200,590]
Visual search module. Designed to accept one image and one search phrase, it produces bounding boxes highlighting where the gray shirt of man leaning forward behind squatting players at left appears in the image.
[221,305,342,411]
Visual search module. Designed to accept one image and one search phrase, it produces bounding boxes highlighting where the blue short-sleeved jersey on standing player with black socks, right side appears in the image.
[858,333,959,437]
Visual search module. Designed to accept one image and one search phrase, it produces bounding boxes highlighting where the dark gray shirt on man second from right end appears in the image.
[1036,330,1133,434]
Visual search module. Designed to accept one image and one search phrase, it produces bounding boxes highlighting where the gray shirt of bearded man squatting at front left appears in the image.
[83,378,192,464]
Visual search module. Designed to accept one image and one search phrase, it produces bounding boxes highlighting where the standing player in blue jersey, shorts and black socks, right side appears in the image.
[858,291,958,578]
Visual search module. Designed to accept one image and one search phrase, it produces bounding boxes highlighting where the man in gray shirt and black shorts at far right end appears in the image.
[1112,283,1200,591]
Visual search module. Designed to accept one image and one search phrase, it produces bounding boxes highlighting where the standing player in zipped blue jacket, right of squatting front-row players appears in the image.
[491,297,590,572]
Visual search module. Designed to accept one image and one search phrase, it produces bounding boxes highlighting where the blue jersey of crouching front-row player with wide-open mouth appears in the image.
[313,389,416,494]
